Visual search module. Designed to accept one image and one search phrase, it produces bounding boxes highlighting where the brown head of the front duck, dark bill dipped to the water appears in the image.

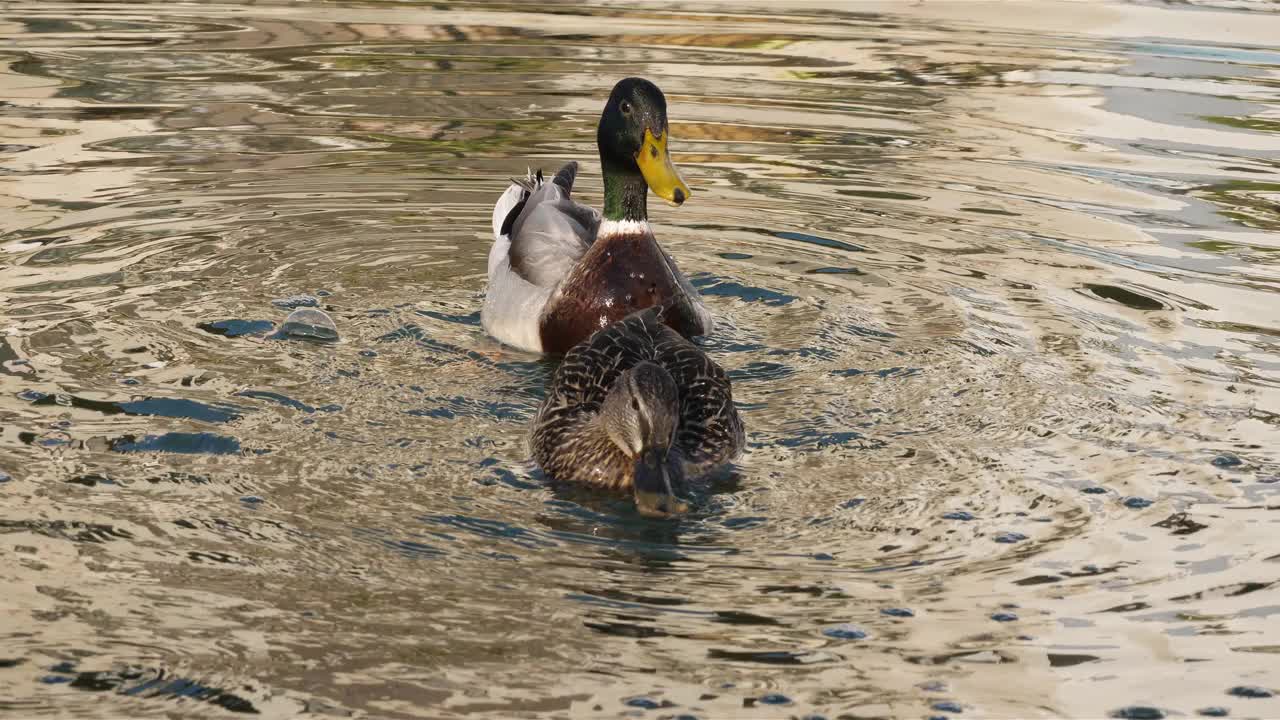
[600,361,689,516]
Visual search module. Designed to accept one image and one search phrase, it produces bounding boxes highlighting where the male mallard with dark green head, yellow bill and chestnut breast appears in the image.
[480,78,712,352]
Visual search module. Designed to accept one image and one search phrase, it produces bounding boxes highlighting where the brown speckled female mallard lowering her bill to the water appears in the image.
[531,307,744,516]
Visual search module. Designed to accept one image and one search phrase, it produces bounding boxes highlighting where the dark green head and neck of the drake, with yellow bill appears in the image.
[595,78,690,220]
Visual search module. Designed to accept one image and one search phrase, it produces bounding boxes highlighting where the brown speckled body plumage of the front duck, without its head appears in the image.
[531,307,745,489]
